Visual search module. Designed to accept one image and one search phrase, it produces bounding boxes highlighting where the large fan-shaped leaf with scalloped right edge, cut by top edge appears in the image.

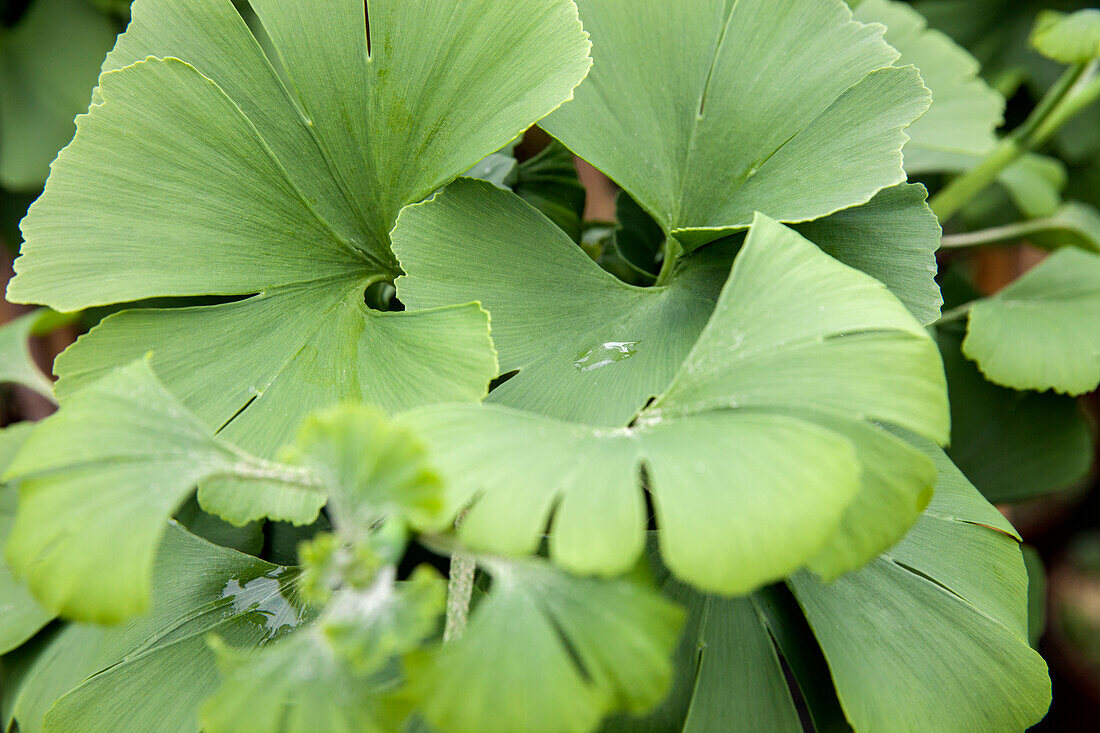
[542,0,930,250]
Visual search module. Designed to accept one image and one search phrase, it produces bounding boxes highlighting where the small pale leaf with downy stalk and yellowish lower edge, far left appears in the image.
[2,360,325,623]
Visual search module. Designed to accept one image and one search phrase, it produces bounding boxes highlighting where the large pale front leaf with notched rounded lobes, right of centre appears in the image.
[399,211,947,593]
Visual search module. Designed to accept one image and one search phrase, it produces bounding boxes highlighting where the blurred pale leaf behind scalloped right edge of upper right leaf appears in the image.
[854,0,1004,175]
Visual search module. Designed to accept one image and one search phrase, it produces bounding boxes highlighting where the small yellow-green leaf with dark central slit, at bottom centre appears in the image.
[415,558,683,733]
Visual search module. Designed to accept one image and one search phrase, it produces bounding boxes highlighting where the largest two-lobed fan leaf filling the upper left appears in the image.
[9,0,591,462]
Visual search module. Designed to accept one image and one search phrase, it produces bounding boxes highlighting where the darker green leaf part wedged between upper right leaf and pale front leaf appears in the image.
[794,184,944,325]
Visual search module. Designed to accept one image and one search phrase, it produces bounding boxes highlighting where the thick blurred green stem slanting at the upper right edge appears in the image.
[928,61,1100,221]
